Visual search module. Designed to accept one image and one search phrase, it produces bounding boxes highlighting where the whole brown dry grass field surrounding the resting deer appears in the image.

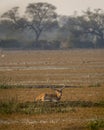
[0,49,104,130]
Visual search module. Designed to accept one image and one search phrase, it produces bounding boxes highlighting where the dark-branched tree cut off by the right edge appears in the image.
[83,9,104,47]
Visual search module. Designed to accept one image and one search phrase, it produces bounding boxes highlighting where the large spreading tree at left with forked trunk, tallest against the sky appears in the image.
[2,2,58,46]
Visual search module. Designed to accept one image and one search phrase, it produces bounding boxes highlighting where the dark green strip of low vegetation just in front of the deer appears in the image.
[0,97,104,114]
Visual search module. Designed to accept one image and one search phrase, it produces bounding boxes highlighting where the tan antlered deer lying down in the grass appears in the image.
[35,86,65,102]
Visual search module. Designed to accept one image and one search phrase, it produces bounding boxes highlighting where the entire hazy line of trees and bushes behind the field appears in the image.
[0,2,104,49]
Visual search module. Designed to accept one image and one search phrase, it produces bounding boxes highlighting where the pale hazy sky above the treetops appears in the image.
[0,0,104,15]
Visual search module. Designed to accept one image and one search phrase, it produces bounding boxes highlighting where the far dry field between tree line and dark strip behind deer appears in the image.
[0,49,104,86]
